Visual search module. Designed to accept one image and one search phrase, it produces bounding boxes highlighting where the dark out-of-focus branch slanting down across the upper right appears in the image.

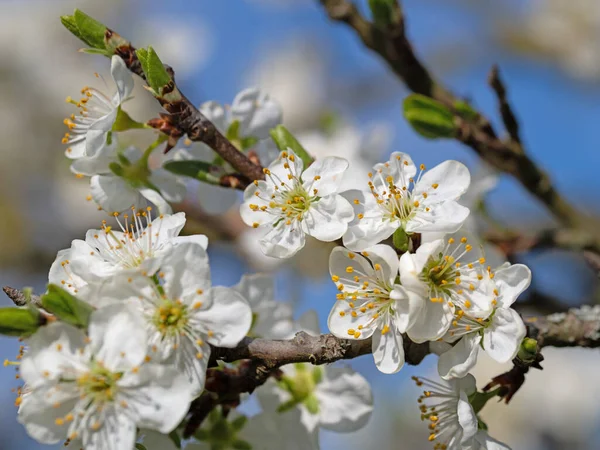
[319,0,600,249]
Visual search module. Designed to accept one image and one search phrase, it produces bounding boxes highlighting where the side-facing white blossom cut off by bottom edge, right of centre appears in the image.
[413,375,479,450]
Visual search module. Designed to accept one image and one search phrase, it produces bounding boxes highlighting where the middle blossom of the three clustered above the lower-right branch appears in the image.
[400,236,495,342]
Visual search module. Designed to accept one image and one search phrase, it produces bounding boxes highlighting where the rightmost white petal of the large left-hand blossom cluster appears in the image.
[194,286,252,348]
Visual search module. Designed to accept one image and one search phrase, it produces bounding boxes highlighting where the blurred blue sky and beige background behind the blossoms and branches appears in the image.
[0,0,600,450]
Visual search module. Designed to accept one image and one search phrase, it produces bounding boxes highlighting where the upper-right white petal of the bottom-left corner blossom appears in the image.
[89,305,148,372]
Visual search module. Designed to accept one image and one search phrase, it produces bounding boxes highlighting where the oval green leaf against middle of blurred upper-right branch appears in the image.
[404,94,456,139]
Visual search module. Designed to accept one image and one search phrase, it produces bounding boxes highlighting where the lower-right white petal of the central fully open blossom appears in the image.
[302,195,354,242]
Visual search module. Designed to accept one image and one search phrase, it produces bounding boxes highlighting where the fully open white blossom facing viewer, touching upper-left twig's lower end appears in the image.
[241,150,352,258]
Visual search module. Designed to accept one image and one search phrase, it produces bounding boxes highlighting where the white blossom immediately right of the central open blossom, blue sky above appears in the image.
[344,152,471,251]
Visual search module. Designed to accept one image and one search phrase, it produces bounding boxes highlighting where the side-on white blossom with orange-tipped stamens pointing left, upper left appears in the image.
[62,55,133,159]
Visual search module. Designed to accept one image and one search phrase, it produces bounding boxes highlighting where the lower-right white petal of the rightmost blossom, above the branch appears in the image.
[483,308,526,363]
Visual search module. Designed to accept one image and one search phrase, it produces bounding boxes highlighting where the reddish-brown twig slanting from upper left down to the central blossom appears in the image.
[106,30,264,180]
